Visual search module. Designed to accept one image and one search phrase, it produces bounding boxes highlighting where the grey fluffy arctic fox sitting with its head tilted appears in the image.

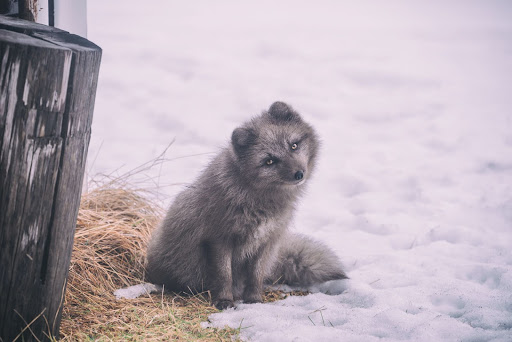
[146,102,347,309]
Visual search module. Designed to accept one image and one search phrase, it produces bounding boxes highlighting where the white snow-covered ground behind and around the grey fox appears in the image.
[88,0,512,341]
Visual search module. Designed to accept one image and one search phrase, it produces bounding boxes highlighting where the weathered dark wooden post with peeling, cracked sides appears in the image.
[0,15,101,341]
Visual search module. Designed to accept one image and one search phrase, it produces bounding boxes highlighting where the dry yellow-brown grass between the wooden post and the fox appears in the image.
[60,170,304,341]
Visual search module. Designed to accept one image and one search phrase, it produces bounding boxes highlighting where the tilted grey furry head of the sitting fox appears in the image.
[231,102,319,188]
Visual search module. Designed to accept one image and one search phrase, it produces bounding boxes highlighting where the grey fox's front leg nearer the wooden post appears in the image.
[204,241,234,310]
